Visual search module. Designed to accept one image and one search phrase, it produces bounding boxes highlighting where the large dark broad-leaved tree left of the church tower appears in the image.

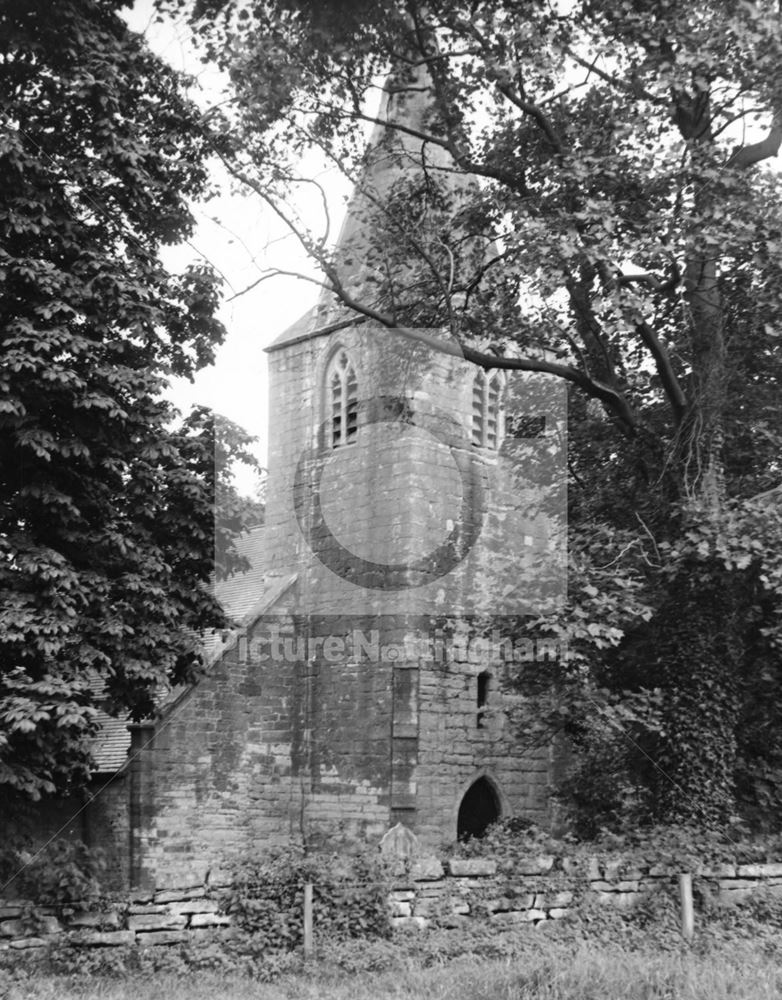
[0,0,233,798]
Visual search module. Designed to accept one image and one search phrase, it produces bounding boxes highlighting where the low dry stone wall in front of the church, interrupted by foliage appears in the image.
[0,854,782,952]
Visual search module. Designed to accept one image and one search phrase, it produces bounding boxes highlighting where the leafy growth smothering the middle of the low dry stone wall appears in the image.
[222,847,390,951]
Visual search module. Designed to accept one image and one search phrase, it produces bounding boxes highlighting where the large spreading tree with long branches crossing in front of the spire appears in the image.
[178,0,782,822]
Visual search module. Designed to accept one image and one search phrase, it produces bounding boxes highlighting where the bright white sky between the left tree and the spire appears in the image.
[125,0,356,492]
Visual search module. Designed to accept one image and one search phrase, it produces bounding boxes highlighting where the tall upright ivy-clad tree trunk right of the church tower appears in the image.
[650,91,748,825]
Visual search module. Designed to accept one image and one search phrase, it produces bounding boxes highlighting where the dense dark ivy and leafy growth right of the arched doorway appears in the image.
[536,494,782,836]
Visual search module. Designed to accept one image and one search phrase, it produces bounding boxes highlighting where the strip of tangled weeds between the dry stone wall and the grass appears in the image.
[0,893,782,984]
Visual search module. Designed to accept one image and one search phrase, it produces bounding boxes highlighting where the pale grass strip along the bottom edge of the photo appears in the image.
[0,938,782,1000]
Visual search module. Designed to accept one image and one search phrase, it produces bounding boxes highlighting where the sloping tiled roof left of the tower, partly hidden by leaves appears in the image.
[92,525,281,775]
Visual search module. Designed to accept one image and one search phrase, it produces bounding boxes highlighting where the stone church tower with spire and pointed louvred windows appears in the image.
[12,72,564,887]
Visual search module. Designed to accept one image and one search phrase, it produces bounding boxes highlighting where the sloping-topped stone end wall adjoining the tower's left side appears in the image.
[133,609,306,888]
